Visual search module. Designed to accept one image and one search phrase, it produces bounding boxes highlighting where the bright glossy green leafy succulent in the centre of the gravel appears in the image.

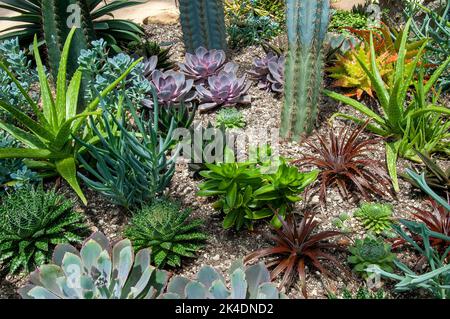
[197,150,318,230]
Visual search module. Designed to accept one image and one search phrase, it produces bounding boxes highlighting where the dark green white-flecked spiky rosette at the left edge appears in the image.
[0,186,87,274]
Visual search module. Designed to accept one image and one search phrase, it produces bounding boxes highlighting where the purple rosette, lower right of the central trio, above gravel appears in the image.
[196,62,251,111]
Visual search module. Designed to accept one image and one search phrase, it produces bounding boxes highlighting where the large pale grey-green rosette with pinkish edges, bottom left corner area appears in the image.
[19,232,169,299]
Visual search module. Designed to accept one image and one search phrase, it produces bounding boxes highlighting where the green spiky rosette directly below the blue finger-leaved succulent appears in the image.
[125,199,208,267]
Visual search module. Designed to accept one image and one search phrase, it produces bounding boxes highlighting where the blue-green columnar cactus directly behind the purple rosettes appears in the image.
[179,0,227,53]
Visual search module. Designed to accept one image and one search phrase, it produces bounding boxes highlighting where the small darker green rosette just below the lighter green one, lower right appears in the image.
[348,236,396,278]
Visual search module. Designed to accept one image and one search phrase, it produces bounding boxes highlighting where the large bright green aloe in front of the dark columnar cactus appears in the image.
[0,28,140,204]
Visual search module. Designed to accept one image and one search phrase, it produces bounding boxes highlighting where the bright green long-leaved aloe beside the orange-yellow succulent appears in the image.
[325,21,450,191]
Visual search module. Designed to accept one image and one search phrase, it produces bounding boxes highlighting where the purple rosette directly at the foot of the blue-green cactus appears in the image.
[178,47,226,83]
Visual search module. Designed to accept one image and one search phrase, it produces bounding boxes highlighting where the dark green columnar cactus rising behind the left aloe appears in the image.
[41,0,95,79]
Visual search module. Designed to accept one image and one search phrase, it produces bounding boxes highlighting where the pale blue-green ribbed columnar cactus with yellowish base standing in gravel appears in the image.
[280,0,330,140]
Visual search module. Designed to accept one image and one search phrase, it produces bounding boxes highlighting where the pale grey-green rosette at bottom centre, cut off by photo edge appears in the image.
[161,260,287,299]
